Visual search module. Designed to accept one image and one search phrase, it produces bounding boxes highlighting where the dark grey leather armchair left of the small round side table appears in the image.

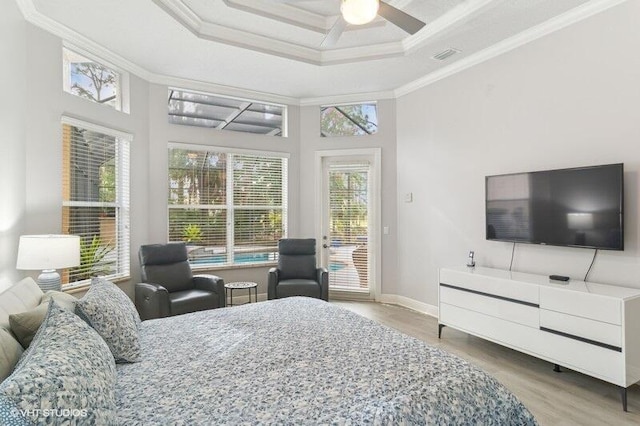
[135,243,226,320]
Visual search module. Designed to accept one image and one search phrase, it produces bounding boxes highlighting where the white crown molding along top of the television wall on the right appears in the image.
[394,0,628,98]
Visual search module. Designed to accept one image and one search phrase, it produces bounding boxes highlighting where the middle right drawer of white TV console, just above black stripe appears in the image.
[540,309,622,348]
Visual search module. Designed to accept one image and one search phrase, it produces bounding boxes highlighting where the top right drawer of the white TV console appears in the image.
[540,287,622,325]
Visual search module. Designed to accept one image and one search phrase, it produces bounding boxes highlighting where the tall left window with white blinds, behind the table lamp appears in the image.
[62,117,131,286]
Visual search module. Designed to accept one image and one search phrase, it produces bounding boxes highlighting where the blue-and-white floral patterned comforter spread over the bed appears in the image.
[116,297,536,425]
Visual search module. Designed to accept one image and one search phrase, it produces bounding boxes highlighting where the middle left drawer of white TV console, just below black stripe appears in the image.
[440,286,539,328]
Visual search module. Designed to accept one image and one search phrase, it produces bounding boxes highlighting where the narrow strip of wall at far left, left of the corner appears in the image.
[0,2,27,292]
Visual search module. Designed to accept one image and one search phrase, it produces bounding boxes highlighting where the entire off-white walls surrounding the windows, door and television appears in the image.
[12,2,640,305]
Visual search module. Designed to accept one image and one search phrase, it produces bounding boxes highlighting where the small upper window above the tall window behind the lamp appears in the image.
[62,48,127,110]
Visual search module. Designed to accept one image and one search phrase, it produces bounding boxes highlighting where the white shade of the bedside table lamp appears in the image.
[16,235,80,271]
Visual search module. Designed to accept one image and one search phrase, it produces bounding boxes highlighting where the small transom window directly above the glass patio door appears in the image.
[320,102,378,137]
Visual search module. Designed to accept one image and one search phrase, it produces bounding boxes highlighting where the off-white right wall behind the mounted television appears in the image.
[397,2,640,305]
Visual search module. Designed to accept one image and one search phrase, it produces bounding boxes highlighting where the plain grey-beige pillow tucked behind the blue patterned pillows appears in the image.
[9,291,78,349]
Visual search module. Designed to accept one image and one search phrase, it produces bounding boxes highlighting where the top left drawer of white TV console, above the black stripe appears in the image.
[440,269,539,305]
